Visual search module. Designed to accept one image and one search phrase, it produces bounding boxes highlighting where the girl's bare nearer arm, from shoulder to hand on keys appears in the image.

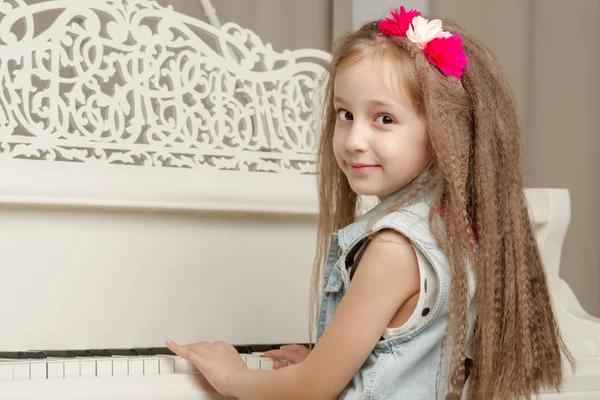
[168,230,420,400]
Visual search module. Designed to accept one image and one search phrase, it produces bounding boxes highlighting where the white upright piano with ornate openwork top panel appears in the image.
[0,0,600,400]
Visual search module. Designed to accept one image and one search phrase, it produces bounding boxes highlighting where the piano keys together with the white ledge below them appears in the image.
[0,345,302,400]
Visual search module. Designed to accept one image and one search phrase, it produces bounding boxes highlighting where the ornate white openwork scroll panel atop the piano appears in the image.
[0,0,330,174]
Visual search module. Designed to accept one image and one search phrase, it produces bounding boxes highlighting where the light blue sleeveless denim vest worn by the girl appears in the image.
[317,192,476,400]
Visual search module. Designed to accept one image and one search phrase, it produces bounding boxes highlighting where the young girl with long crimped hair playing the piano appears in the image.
[167,7,572,400]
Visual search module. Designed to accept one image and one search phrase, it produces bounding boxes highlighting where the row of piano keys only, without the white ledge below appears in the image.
[0,345,298,382]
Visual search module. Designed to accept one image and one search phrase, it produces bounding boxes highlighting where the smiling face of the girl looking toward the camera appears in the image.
[333,57,429,200]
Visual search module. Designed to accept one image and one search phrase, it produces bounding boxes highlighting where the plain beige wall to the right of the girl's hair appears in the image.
[433,0,600,315]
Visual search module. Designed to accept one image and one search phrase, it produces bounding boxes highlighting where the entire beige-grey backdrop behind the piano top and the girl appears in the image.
[162,0,600,315]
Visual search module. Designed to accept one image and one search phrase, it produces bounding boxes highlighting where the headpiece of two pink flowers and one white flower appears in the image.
[378,7,469,79]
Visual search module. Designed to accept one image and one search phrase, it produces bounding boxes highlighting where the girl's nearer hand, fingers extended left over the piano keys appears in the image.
[166,340,248,396]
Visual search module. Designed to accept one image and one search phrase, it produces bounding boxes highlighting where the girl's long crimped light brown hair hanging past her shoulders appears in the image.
[310,17,572,400]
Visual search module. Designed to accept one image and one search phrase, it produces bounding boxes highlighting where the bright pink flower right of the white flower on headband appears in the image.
[423,36,469,79]
